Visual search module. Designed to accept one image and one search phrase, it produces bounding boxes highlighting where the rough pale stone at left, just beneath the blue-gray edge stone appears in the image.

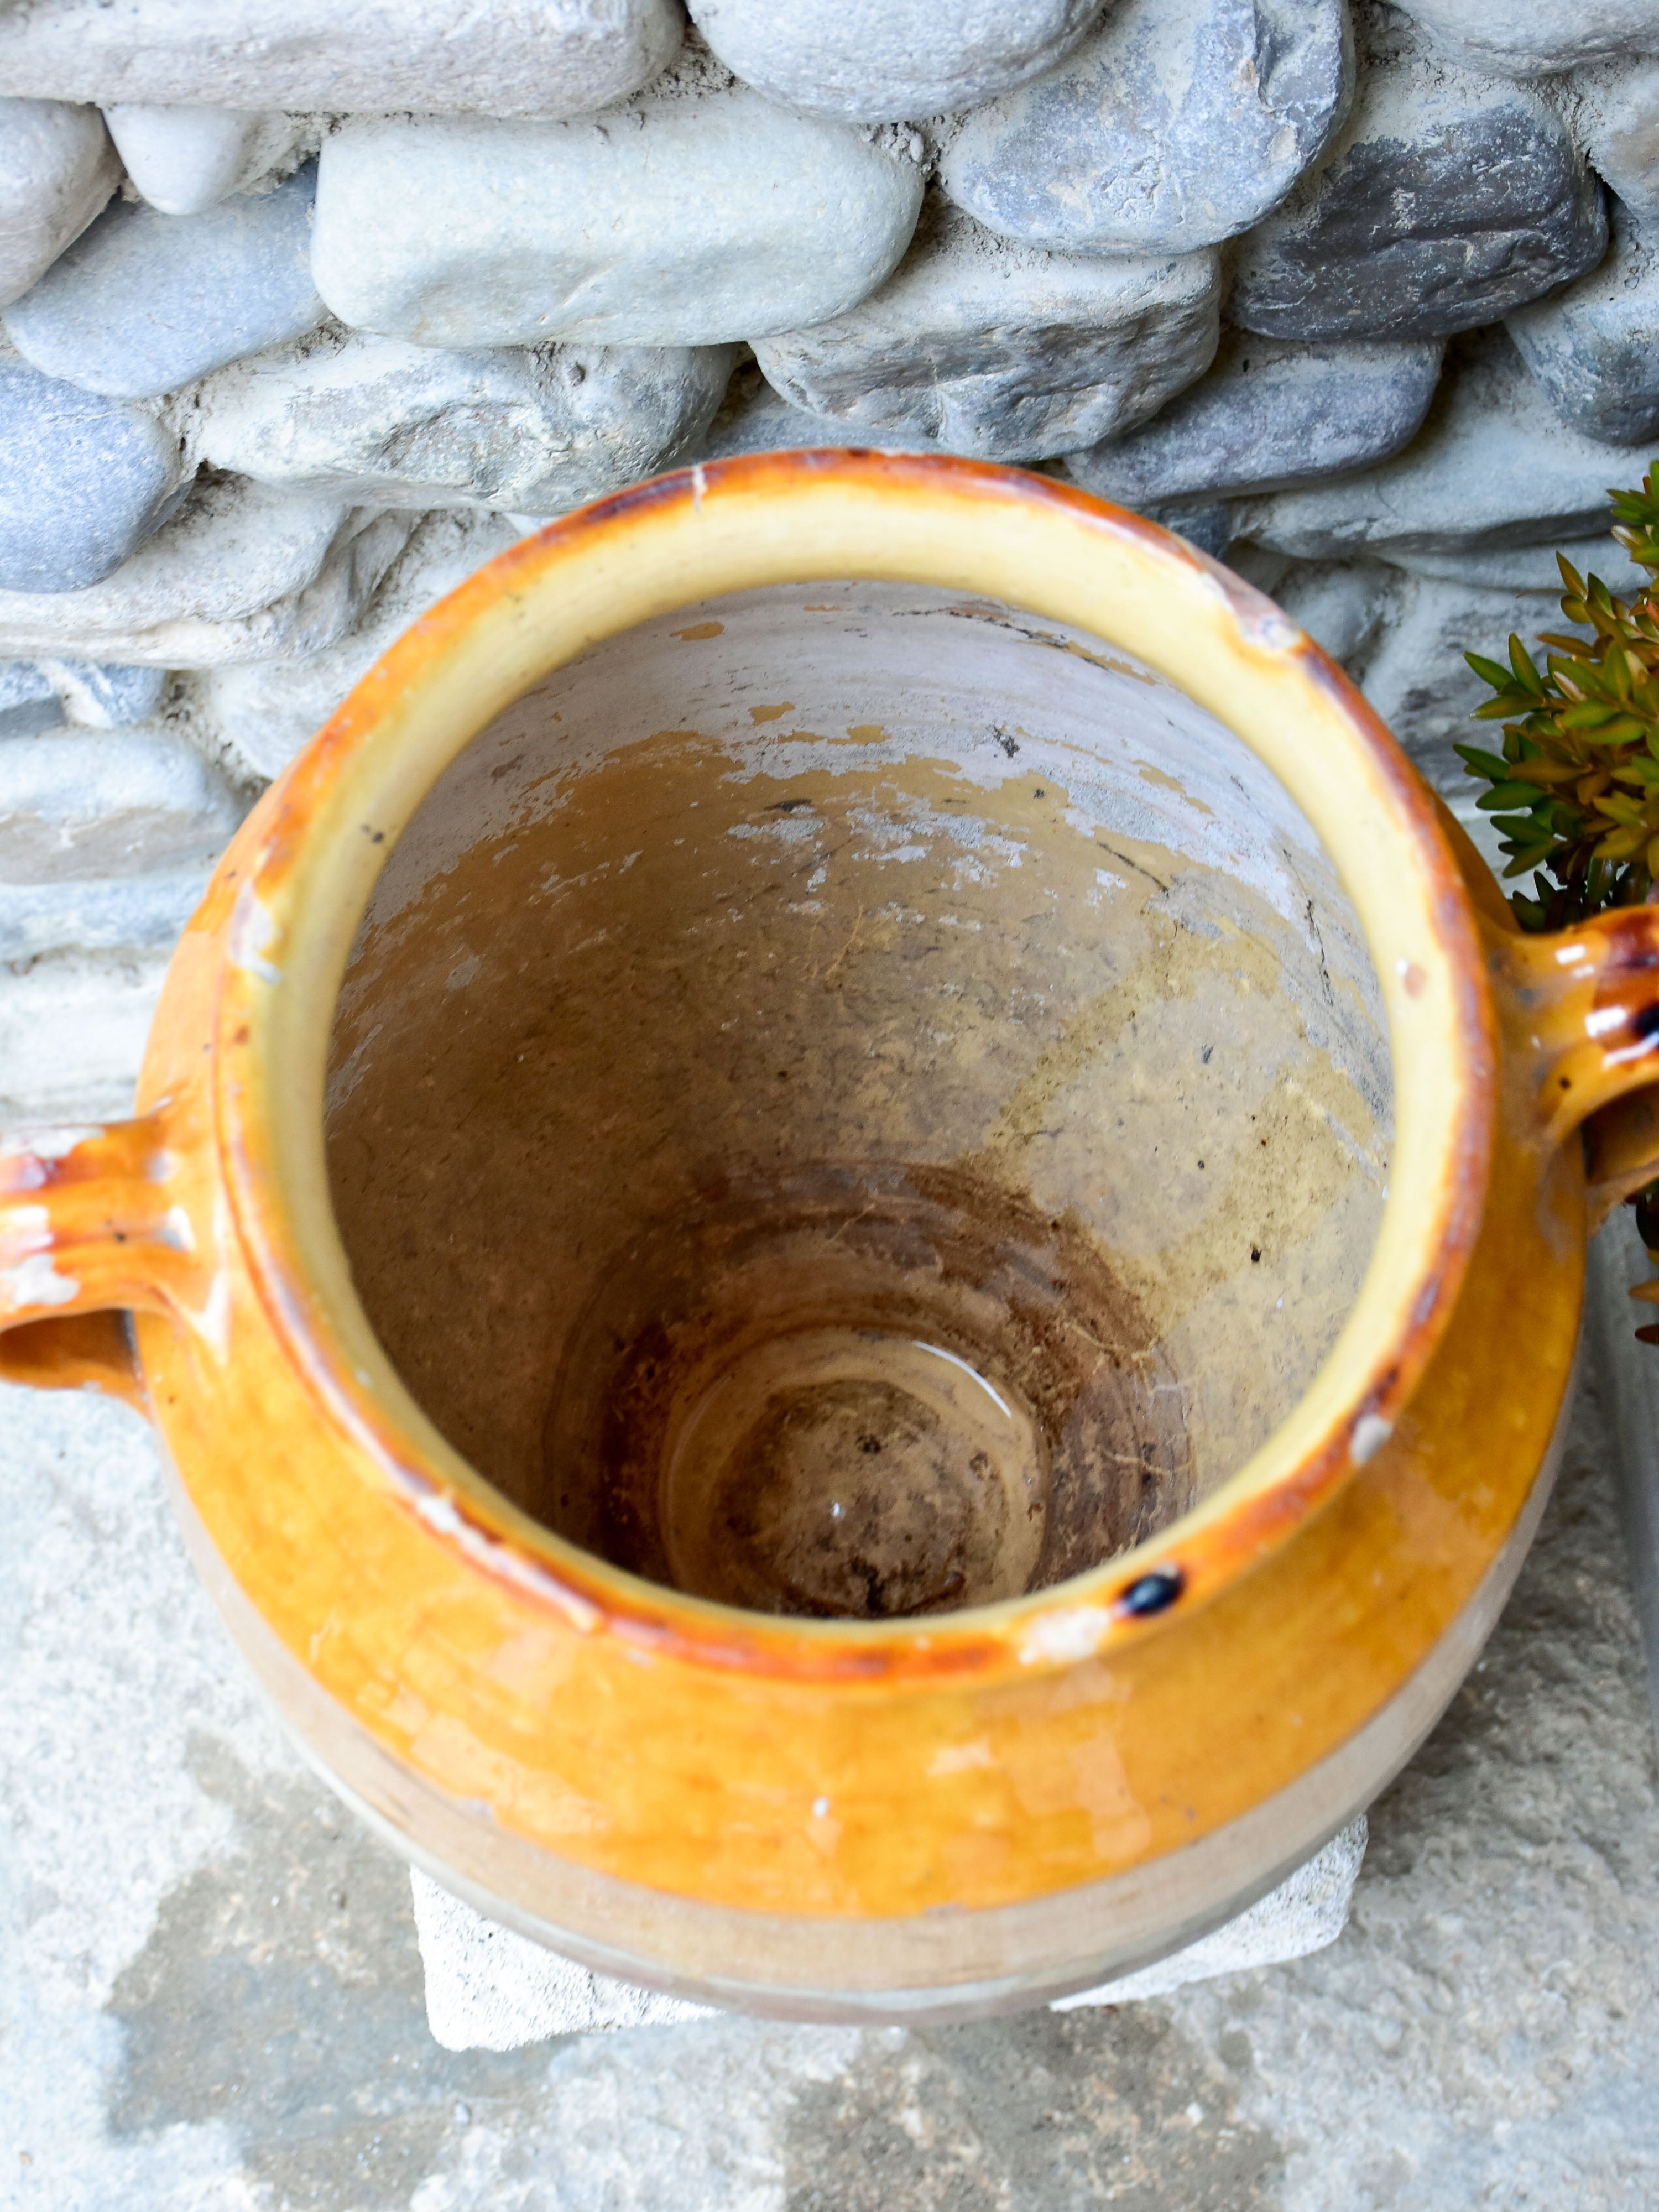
[0,478,416,668]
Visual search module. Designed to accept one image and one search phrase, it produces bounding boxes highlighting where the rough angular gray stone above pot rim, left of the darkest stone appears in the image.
[754,199,1221,460]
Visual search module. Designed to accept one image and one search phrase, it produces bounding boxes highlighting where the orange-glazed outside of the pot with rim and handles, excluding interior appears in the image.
[0,456,1655,2013]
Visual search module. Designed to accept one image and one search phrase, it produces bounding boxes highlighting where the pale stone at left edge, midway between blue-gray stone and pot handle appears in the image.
[0,732,241,889]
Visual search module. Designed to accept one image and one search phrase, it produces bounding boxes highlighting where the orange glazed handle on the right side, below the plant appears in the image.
[1491,907,1659,1228]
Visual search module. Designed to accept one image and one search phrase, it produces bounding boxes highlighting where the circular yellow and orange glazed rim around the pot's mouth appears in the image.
[212,449,1495,1683]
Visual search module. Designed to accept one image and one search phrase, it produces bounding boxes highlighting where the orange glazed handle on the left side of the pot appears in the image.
[0,1102,199,1409]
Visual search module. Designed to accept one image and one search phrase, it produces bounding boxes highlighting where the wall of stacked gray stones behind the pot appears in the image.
[0,0,1659,1117]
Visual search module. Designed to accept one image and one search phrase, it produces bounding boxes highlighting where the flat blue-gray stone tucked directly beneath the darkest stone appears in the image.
[1068,330,1442,507]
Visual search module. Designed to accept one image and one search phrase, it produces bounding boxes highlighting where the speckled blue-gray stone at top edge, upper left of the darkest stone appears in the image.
[940,0,1354,254]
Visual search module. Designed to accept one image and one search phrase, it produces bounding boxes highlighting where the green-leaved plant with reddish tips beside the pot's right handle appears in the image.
[1458,460,1659,1345]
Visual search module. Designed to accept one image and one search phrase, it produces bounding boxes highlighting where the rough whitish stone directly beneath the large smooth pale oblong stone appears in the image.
[197,330,734,513]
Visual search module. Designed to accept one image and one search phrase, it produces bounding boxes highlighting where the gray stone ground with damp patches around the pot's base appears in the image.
[0,1292,1659,2212]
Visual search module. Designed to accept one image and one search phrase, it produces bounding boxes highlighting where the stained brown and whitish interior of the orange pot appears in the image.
[327,582,1391,1619]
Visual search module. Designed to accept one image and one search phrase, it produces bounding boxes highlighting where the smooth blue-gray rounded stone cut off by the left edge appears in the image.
[0,363,186,593]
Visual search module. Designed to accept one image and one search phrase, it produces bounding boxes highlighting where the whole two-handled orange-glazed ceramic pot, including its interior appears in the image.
[0,453,1659,2020]
